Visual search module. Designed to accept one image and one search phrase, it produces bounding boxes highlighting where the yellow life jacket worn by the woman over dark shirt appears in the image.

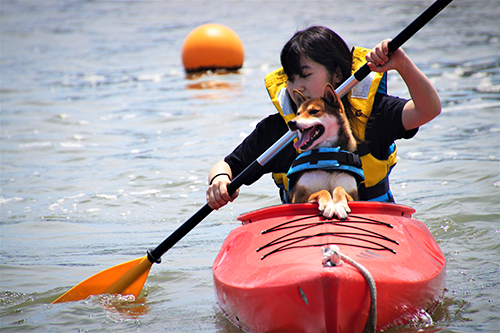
[265,47,397,201]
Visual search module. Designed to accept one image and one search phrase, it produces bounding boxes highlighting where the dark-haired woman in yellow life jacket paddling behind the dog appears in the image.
[207,26,441,209]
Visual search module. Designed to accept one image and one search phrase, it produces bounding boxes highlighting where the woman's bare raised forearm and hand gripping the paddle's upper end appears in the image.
[366,39,441,130]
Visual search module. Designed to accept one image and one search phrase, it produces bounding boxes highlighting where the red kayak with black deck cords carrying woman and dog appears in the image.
[213,202,446,332]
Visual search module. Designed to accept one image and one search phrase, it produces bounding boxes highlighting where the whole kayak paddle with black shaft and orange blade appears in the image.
[53,0,452,303]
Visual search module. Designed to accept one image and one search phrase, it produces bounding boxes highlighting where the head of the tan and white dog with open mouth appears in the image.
[288,83,355,151]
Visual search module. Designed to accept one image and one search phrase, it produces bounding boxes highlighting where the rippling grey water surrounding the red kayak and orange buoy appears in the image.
[0,0,500,332]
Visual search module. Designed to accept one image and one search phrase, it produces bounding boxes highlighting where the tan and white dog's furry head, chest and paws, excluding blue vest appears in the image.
[287,84,358,219]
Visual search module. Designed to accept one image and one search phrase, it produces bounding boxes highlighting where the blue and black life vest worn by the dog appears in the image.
[286,147,365,188]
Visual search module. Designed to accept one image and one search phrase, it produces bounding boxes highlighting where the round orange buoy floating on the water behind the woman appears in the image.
[182,23,244,72]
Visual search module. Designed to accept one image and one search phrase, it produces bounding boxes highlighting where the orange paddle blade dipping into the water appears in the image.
[52,256,152,303]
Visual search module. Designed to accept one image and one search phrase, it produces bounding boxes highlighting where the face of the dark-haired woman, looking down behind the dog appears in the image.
[286,56,340,104]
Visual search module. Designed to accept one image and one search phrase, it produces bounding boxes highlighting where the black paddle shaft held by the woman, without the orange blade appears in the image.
[148,0,453,263]
